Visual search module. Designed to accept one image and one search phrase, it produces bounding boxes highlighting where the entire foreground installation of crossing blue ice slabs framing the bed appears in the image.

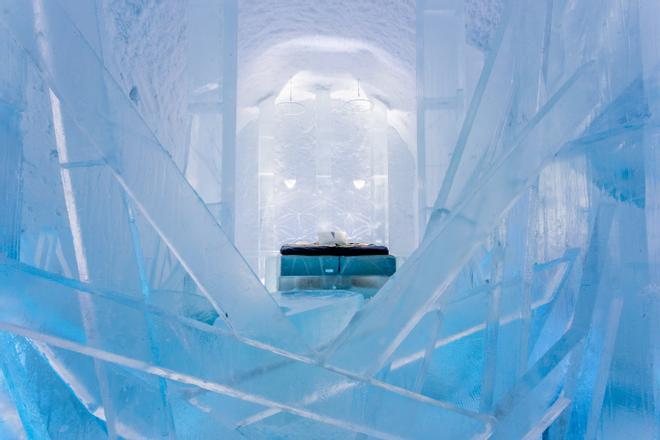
[0,0,660,439]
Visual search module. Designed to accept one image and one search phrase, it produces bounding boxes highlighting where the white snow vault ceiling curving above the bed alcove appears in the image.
[238,0,415,139]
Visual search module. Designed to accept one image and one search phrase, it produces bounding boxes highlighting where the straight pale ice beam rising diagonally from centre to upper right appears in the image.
[328,63,601,374]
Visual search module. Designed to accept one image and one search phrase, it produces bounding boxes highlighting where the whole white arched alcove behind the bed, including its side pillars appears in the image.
[237,62,416,276]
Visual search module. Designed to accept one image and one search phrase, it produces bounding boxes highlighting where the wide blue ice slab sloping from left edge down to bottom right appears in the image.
[0,265,488,438]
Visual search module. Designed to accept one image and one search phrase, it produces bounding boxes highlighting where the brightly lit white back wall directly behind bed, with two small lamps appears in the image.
[258,74,389,262]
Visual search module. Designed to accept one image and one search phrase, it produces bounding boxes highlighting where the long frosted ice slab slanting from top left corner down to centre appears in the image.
[2,2,307,352]
